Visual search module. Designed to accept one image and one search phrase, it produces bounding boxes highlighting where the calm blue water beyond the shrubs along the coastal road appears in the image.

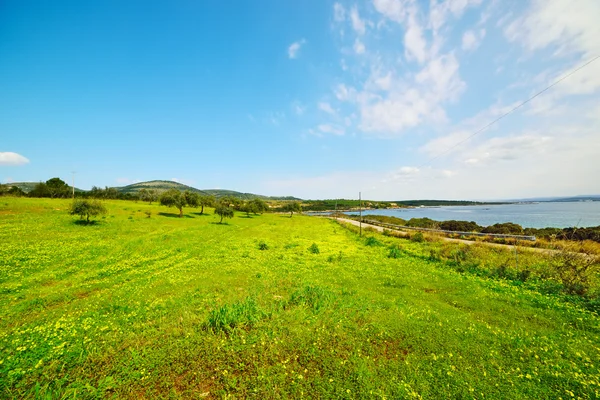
[349,201,600,228]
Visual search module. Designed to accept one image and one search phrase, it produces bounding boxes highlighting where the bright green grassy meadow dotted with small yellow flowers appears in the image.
[0,198,600,399]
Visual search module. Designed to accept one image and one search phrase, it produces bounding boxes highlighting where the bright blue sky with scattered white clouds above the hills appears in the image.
[0,0,600,200]
